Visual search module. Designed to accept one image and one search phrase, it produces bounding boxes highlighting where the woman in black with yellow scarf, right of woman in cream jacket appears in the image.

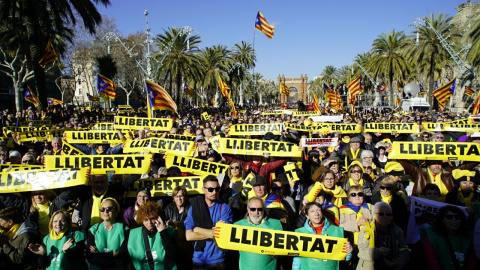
[372,178,409,232]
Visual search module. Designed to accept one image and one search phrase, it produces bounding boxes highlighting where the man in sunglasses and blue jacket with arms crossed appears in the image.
[185,175,233,269]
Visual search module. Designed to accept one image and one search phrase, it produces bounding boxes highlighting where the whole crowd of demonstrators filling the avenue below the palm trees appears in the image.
[0,104,480,270]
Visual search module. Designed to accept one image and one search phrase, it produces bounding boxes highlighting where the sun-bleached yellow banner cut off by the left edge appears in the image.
[0,168,89,193]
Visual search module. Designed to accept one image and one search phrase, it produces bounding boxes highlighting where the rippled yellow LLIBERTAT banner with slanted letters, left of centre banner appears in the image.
[123,138,195,156]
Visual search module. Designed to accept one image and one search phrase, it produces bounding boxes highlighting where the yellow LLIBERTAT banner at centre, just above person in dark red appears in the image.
[215,138,303,157]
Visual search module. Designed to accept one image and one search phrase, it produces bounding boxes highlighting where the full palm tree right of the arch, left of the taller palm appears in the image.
[367,30,411,105]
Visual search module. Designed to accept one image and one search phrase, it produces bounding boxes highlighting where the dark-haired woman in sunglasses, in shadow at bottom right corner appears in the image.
[423,205,479,269]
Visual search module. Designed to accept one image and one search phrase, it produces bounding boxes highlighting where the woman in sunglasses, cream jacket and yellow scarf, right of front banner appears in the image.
[340,186,373,248]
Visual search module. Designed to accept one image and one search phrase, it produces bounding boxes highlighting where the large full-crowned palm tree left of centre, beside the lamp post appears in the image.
[155,27,201,104]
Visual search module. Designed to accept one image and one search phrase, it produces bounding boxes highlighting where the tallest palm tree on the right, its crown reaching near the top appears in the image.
[407,13,455,103]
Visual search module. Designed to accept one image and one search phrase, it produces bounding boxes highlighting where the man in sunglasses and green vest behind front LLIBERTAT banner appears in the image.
[235,197,282,270]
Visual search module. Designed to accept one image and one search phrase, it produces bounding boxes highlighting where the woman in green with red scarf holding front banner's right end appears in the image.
[292,202,353,270]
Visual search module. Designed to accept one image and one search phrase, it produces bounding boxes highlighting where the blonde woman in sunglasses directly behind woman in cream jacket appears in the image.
[343,160,373,202]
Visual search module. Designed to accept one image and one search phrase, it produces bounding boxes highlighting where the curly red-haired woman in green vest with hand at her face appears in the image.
[128,202,178,270]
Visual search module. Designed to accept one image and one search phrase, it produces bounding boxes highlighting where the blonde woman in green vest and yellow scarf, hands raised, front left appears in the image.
[28,210,88,270]
